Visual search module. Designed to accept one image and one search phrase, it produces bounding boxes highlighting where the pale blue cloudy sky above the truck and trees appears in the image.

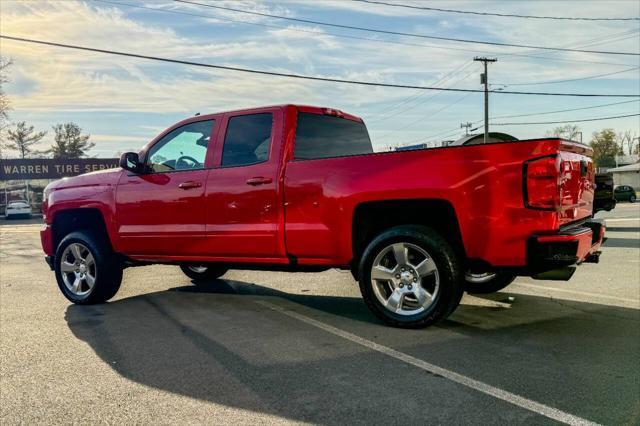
[1,0,639,156]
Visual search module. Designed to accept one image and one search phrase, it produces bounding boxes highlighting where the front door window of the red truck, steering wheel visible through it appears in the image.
[147,120,215,173]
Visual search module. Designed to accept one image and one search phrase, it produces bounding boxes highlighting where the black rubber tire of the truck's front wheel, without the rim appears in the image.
[55,231,122,305]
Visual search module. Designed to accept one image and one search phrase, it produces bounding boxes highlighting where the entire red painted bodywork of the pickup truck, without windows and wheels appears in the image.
[42,105,594,274]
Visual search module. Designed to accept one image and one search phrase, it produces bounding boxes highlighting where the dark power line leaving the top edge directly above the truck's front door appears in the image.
[173,0,640,56]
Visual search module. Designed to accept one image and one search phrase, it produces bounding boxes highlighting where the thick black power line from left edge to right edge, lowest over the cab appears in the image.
[0,35,640,98]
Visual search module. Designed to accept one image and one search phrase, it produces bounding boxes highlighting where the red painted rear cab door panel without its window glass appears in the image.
[201,107,288,262]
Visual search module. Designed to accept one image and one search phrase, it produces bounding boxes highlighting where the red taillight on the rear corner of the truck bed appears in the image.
[524,155,560,210]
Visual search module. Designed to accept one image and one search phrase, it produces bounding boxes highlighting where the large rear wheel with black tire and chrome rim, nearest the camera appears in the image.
[359,225,463,328]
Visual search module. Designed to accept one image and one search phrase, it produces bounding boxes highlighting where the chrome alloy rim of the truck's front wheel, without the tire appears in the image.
[60,243,97,297]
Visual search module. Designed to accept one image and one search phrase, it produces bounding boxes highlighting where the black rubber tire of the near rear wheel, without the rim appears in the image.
[358,225,463,328]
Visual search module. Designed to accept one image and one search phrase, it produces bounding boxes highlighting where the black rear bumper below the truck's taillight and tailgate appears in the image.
[527,219,605,279]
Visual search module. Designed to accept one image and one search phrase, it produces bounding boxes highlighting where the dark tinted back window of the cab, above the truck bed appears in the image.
[295,112,373,160]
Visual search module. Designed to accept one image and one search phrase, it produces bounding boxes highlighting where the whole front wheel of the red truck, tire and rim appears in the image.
[55,231,122,305]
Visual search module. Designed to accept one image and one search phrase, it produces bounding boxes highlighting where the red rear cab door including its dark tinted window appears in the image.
[206,108,286,262]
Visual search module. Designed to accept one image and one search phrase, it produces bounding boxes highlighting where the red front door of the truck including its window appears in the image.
[116,119,220,256]
